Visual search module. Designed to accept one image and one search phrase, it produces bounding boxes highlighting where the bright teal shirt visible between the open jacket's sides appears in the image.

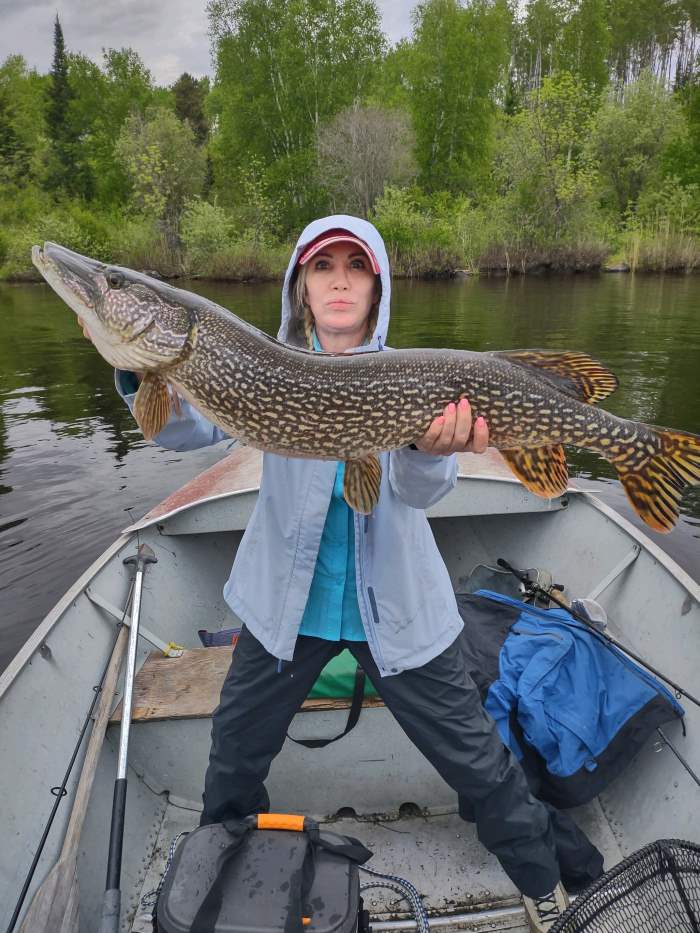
[299,334,367,641]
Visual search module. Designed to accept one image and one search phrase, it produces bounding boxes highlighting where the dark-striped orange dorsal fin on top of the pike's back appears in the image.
[493,350,619,404]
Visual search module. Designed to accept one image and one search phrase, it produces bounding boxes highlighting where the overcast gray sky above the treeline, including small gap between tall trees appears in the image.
[0,0,416,84]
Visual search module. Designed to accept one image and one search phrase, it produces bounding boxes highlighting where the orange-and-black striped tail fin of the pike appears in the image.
[604,425,700,533]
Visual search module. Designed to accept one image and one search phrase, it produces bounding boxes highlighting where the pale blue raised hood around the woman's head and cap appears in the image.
[277,214,391,350]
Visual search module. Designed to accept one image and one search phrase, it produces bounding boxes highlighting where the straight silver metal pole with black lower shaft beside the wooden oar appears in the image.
[99,544,157,933]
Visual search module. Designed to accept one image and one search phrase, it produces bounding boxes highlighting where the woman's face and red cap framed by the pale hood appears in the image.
[306,243,377,349]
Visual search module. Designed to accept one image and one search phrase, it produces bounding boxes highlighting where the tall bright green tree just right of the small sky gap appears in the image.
[407,0,510,192]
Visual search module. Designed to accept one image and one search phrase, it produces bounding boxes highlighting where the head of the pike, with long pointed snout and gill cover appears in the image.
[32,242,196,372]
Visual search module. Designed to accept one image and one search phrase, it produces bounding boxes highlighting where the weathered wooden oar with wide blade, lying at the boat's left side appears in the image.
[20,626,129,933]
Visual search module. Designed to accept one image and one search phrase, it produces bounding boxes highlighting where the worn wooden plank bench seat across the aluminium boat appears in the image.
[110,646,384,722]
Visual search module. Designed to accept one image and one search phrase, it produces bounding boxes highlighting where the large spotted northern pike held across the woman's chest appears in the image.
[32,243,700,532]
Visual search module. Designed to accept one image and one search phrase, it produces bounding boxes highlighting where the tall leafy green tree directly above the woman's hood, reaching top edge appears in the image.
[207,0,384,223]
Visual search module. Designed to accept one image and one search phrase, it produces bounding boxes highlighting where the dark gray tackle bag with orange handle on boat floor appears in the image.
[154,813,372,933]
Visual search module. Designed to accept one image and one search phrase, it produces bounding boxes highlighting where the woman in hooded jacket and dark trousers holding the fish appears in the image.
[101,215,566,931]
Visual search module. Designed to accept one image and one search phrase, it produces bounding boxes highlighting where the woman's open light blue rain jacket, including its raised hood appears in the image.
[116,214,462,676]
